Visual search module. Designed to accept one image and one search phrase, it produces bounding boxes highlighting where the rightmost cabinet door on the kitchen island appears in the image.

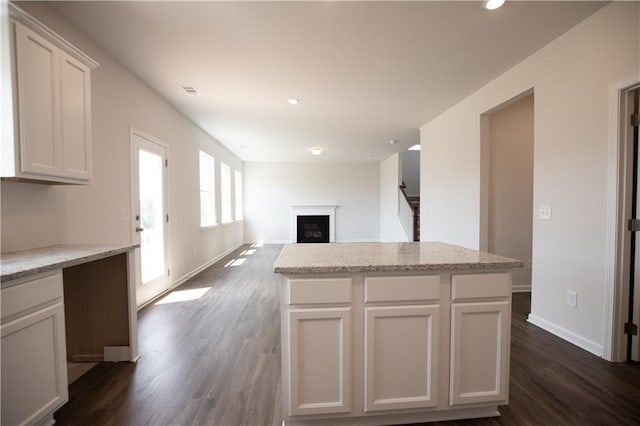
[449,301,511,405]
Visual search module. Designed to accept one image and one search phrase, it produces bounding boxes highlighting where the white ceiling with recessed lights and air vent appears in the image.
[45,1,604,161]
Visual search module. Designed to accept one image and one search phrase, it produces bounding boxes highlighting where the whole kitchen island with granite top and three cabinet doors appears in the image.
[274,242,522,425]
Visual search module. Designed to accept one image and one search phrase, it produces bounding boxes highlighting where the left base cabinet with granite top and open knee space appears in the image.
[0,244,139,424]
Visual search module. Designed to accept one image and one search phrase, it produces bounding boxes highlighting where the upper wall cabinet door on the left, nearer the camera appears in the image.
[16,24,62,176]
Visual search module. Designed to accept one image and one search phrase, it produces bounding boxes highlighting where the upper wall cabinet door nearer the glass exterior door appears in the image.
[60,52,91,180]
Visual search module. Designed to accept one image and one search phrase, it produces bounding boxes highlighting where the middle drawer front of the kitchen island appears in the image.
[364,275,440,303]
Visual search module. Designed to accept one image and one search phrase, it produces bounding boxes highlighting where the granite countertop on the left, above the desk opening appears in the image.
[0,244,140,284]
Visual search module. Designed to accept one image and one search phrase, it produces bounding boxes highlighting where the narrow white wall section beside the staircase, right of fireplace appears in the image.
[380,154,410,242]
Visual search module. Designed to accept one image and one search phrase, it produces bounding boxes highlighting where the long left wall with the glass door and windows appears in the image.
[2,3,243,282]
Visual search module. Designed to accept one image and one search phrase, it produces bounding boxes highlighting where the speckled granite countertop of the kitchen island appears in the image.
[274,242,523,274]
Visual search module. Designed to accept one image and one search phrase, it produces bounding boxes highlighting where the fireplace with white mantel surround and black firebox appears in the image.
[290,205,338,243]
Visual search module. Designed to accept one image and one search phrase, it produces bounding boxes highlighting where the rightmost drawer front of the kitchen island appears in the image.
[451,272,511,300]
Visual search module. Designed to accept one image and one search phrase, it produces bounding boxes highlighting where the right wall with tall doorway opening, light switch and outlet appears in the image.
[421,2,640,354]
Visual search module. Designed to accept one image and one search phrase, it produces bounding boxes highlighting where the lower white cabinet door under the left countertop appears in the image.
[2,302,69,425]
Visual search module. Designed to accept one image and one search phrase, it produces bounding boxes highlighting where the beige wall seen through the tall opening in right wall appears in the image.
[481,95,534,290]
